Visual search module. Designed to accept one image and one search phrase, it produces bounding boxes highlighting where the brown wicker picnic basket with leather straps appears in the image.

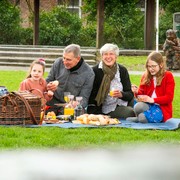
[0,91,41,125]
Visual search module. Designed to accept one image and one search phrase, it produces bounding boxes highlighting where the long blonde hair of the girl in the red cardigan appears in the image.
[142,51,166,86]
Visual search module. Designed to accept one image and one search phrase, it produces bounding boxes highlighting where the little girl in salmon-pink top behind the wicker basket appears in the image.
[19,58,59,105]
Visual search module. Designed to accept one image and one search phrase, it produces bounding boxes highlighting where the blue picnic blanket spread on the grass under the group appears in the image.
[26,118,180,130]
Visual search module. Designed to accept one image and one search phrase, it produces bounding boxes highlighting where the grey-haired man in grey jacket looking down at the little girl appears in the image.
[46,44,94,114]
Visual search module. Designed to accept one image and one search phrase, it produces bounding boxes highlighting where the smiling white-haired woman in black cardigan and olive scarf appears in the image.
[87,43,135,118]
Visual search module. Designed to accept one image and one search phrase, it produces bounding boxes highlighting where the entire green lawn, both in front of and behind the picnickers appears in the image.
[0,57,180,149]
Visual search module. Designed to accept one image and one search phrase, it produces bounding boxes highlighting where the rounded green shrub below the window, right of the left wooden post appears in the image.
[39,6,82,46]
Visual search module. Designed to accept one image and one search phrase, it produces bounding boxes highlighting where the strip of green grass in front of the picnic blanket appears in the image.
[0,127,180,150]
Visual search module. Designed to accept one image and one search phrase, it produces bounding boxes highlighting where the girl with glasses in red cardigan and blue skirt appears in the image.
[126,52,175,123]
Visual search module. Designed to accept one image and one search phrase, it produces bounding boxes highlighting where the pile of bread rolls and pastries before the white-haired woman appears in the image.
[73,114,120,125]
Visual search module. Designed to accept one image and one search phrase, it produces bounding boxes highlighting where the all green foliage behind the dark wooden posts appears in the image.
[0,0,180,49]
